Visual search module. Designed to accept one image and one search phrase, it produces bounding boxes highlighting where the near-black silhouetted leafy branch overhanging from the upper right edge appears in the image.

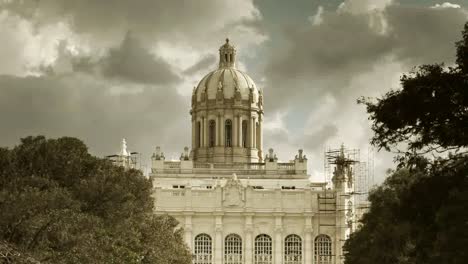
[358,23,468,162]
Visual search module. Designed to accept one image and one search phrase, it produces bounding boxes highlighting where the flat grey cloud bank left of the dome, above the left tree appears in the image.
[0,73,190,161]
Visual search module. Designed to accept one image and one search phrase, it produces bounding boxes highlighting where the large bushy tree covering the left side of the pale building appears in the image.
[0,136,190,264]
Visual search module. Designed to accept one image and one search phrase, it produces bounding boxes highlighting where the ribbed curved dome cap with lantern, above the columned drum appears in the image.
[194,39,261,103]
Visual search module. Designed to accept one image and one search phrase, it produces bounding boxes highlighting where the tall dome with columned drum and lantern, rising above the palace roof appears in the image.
[190,39,263,163]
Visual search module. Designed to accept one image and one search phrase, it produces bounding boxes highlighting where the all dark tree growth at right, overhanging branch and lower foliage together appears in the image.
[344,23,468,264]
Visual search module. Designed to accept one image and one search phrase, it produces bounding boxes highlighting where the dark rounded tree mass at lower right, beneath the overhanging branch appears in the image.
[344,158,468,264]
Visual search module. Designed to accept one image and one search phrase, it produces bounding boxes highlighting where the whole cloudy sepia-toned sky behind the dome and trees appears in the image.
[0,0,468,183]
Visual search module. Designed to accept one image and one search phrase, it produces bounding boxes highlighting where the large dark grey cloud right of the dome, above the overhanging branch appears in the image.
[266,5,467,108]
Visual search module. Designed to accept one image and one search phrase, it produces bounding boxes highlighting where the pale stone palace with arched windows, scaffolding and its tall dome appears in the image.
[150,40,355,264]
